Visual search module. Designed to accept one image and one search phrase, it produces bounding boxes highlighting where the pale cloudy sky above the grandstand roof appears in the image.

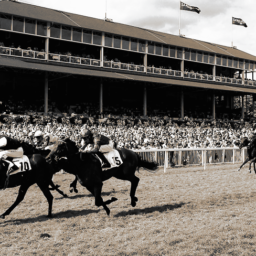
[20,0,256,55]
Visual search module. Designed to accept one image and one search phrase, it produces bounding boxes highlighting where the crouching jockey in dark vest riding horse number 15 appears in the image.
[80,129,114,168]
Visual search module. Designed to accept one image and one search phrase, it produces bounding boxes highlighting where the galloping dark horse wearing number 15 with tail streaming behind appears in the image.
[50,139,157,215]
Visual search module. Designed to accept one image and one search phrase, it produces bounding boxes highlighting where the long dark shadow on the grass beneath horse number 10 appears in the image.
[0,209,100,227]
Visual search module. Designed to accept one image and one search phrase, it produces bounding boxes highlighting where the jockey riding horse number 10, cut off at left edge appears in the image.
[0,136,24,173]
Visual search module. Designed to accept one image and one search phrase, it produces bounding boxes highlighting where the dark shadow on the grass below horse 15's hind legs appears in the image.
[115,203,185,217]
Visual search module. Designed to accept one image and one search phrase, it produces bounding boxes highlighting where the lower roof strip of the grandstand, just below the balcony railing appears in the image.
[0,56,256,94]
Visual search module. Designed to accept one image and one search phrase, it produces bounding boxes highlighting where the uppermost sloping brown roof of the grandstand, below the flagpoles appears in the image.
[0,1,256,61]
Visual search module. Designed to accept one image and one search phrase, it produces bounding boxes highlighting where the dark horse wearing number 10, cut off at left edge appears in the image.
[0,154,58,219]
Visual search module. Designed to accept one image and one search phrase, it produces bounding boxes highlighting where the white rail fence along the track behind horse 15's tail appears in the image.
[134,148,247,172]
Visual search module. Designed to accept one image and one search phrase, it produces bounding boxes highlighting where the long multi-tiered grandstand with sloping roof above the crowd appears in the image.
[0,1,256,119]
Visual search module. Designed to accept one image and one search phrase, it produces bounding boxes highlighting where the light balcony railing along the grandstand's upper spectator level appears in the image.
[0,46,256,86]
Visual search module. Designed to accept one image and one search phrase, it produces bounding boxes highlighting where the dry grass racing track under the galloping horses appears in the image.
[0,165,256,256]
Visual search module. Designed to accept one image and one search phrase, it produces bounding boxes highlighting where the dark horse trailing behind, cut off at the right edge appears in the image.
[238,137,256,173]
